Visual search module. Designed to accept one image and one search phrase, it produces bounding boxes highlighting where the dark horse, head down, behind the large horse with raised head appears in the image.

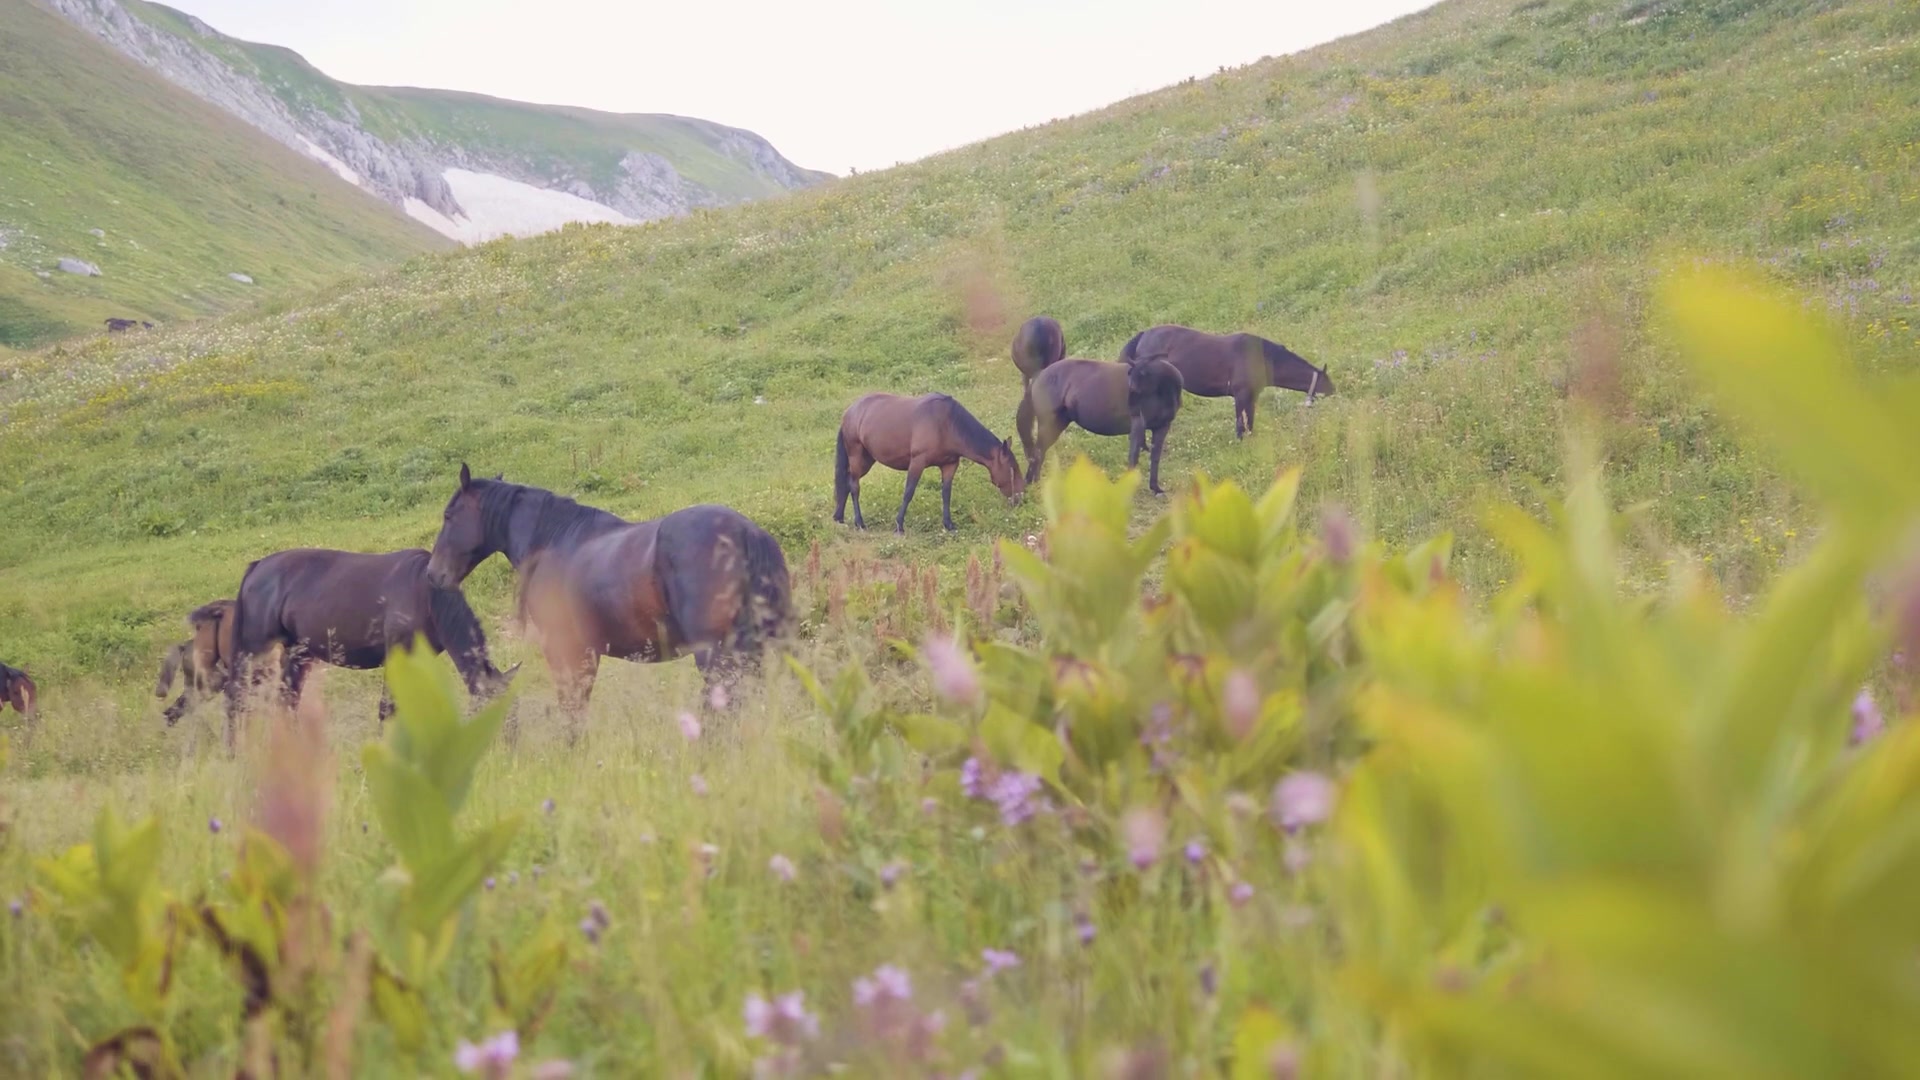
[227,548,520,748]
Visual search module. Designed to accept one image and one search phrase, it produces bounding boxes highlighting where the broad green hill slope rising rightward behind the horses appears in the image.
[0,0,1920,671]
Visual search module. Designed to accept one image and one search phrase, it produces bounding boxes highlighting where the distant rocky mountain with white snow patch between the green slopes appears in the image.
[50,0,828,242]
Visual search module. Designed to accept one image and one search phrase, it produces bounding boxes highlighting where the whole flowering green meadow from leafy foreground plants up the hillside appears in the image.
[0,0,1920,1076]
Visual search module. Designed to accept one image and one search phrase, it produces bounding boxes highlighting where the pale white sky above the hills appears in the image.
[167,0,1430,173]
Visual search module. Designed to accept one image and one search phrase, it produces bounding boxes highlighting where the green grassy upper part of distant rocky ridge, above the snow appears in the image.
[127,0,828,202]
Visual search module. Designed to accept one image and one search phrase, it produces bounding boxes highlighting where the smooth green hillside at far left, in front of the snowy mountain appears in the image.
[0,0,447,348]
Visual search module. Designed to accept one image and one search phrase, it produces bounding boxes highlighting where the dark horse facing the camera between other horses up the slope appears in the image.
[1027,359,1181,496]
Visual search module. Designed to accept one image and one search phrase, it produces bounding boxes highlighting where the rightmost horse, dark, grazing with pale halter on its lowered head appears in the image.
[1119,325,1332,438]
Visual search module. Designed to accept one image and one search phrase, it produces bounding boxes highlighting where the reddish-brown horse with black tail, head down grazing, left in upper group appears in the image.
[833,394,1027,532]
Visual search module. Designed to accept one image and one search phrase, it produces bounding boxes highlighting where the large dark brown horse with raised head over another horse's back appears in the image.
[426,465,791,719]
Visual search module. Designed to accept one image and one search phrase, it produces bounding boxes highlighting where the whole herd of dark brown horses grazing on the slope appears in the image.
[0,315,1334,734]
